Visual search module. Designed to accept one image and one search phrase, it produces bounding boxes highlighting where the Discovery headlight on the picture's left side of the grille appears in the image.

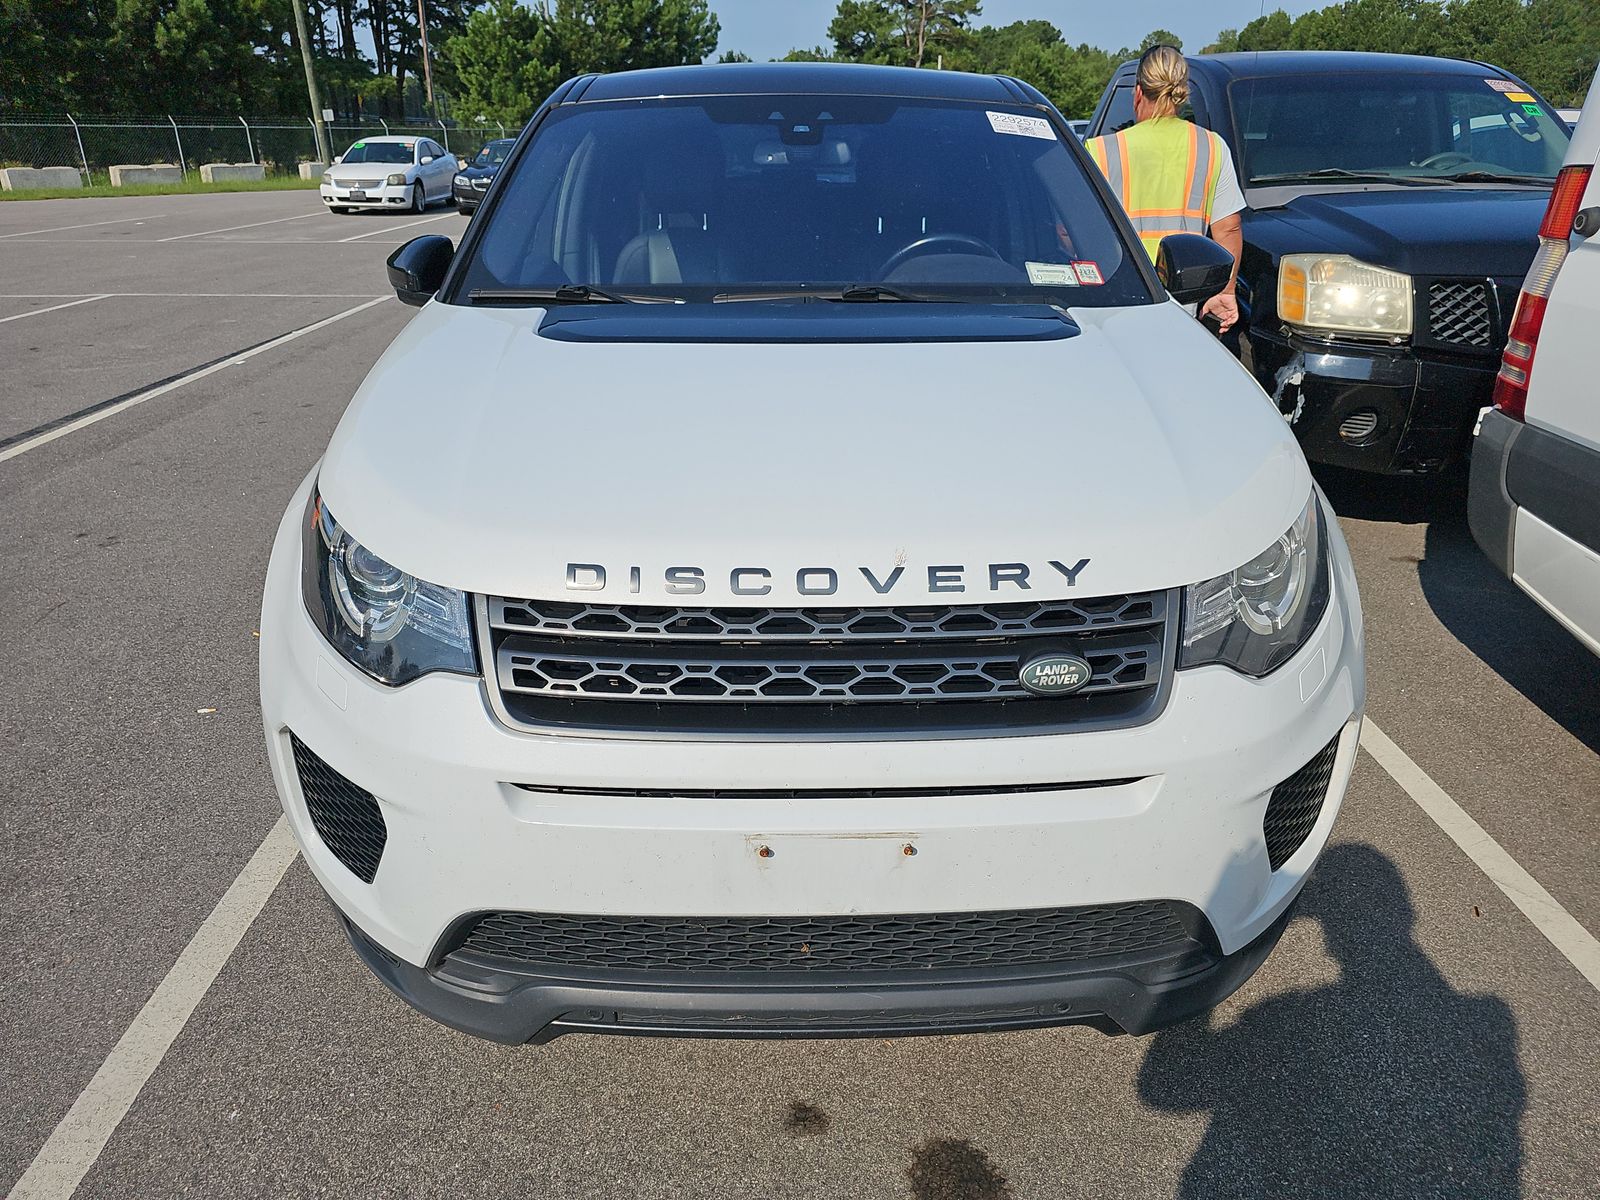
[301,491,478,686]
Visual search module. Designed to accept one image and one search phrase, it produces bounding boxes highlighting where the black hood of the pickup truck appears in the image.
[1245,184,1550,280]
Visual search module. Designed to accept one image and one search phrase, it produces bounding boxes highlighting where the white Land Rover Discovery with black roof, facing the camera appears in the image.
[261,64,1365,1042]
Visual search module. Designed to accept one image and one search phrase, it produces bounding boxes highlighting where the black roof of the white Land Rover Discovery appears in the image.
[576,62,1043,104]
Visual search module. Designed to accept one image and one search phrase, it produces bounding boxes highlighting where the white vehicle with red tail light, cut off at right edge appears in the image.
[1467,68,1600,654]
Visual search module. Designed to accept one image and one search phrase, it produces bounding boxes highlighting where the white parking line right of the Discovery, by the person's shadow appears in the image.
[1362,718,1600,990]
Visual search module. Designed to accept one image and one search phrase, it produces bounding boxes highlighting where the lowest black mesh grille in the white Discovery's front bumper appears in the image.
[454,901,1203,973]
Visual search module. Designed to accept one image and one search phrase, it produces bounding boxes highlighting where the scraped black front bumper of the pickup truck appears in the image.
[1248,328,1499,475]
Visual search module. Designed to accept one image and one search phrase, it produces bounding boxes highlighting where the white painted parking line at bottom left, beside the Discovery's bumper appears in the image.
[10,816,299,1200]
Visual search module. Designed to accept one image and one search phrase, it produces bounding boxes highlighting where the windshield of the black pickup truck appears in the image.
[1229,69,1568,186]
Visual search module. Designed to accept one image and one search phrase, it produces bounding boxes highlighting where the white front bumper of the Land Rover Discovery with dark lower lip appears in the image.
[261,480,1365,1040]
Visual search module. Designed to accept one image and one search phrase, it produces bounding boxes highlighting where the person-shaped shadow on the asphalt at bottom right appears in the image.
[1139,845,1526,1200]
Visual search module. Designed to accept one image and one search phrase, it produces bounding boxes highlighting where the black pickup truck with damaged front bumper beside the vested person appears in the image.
[1088,51,1568,474]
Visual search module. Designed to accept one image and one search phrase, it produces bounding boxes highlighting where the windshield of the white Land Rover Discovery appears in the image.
[456,96,1150,306]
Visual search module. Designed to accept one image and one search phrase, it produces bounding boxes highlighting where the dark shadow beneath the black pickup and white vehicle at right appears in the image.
[1317,467,1600,754]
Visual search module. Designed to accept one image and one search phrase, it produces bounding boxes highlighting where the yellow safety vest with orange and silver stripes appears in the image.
[1083,117,1222,262]
